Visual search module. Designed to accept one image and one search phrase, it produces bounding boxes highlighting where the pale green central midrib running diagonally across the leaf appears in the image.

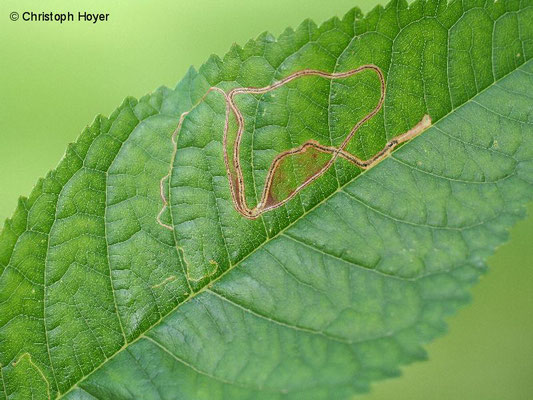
[56,56,531,399]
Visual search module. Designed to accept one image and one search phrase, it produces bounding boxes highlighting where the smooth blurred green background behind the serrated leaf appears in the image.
[0,0,533,400]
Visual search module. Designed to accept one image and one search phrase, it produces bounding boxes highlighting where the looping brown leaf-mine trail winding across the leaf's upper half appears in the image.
[157,64,431,230]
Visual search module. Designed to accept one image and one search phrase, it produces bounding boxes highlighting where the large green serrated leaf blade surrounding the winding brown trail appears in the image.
[0,0,533,399]
